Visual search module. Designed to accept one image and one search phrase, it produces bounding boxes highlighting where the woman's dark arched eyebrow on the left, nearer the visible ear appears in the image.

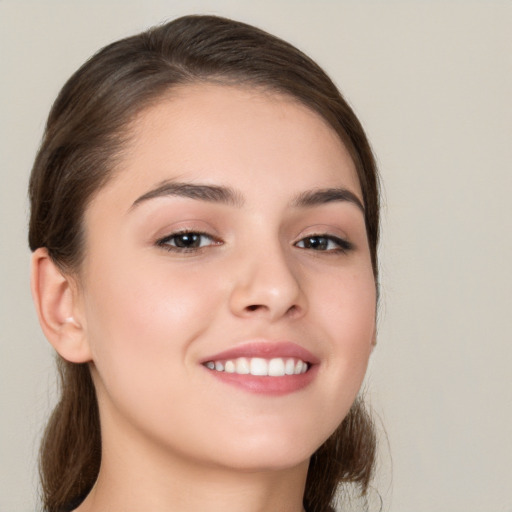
[130,181,244,211]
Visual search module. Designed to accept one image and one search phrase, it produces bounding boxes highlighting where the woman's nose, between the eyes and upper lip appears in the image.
[230,244,307,321]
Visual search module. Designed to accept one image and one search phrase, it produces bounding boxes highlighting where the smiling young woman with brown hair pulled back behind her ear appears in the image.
[29,16,379,512]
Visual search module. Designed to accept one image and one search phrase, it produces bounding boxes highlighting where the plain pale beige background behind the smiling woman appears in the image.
[0,0,512,512]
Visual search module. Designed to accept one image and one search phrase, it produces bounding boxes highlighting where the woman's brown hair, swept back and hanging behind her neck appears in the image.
[29,16,379,512]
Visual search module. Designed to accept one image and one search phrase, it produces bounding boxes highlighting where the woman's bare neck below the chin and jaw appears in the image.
[76,414,309,512]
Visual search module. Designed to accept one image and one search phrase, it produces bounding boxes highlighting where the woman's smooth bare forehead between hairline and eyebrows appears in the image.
[101,84,361,206]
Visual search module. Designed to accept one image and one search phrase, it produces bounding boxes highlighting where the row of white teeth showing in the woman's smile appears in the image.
[205,357,309,377]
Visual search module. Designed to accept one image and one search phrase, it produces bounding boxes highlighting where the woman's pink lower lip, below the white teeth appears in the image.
[205,365,318,396]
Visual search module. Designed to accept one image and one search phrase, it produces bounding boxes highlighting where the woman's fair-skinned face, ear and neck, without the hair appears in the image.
[32,84,376,512]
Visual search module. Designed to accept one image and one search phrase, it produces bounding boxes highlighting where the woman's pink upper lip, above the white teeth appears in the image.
[201,340,320,364]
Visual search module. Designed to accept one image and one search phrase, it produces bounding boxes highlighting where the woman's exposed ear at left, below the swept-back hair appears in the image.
[30,248,92,363]
